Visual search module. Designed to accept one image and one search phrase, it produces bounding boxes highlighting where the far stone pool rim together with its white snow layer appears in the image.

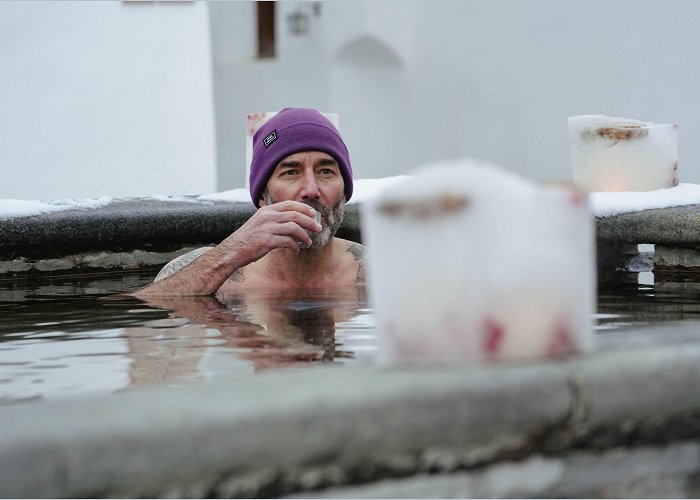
[0,176,700,276]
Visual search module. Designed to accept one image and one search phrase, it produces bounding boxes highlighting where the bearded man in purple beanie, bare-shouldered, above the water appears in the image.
[132,108,365,298]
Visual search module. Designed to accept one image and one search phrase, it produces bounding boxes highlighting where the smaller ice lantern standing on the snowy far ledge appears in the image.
[569,115,678,192]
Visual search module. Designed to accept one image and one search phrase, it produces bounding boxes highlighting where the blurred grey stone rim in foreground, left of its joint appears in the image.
[0,364,570,497]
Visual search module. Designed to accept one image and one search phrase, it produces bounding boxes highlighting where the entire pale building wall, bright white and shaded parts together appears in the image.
[0,0,700,199]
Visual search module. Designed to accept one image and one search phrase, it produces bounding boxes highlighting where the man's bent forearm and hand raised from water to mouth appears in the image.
[131,201,321,298]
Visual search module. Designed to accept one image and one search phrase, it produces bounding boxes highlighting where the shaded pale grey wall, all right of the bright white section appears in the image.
[215,0,700,188]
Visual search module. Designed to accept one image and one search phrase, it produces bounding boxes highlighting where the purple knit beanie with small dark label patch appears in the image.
[250,108,352,207]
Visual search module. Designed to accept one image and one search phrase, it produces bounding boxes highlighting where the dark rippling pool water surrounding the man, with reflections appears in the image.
[0,273,700,406]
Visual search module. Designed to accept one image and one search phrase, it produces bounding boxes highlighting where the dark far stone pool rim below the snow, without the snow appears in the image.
[0,197,700,279]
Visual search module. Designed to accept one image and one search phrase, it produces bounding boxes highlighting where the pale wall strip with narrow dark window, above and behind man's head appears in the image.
[208,2,330,190]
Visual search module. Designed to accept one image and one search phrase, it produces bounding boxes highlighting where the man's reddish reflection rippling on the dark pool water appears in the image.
[133,287,373,383]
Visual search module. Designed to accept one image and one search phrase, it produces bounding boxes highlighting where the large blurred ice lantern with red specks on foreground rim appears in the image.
[362,160,595,363]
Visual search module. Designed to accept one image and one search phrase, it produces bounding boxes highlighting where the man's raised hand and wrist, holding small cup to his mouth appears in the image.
[221,200,322,263]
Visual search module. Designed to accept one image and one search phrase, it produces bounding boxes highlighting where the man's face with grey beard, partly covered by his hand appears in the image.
[260,151,346,248]
